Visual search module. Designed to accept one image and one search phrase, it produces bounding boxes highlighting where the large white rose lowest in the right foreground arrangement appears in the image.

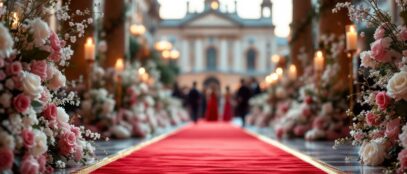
[359,139,386,166]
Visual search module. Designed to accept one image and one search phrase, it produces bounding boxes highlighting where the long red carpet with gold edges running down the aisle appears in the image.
[94,122,325,174]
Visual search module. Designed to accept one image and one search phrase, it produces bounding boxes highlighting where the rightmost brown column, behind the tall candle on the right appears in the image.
[319,0,351,80]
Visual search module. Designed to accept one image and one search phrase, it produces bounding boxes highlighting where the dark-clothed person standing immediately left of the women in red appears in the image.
[187,81,201,123]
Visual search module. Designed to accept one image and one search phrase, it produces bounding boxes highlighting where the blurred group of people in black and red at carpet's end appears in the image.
[172,77,262,127]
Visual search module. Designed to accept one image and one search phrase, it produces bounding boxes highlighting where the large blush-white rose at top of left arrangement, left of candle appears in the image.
[30,18,51,47]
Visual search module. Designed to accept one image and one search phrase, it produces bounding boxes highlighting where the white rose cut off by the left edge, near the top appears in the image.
[0,23,14,58]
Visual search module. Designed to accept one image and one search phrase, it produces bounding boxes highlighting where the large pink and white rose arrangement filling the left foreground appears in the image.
[0,0,99,173]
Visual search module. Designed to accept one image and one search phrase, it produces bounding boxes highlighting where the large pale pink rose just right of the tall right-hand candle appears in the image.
[371,38,391,62]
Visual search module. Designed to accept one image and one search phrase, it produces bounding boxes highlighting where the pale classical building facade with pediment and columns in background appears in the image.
[157,0,286,89]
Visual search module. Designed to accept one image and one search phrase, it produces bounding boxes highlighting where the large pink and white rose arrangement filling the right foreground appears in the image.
[333,0,407,173]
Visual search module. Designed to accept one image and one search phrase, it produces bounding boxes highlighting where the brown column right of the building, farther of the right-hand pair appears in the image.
[290,0,314,74]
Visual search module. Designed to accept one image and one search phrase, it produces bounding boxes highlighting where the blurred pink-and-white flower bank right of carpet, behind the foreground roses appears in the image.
[274,34,349,140]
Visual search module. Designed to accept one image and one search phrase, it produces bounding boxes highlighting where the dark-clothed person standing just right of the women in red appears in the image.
[236,79,252,127]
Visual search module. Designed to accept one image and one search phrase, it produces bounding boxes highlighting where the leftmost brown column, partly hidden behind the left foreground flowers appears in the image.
[62,0,94,80]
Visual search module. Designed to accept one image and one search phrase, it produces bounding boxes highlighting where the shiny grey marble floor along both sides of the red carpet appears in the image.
[61,120,383,174]
